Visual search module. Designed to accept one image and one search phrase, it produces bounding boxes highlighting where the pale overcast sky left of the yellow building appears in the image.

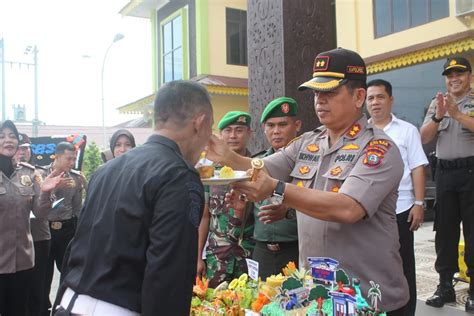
[0,0,152,126]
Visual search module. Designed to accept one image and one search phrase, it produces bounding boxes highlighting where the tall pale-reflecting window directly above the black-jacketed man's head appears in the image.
[161,15,183,82]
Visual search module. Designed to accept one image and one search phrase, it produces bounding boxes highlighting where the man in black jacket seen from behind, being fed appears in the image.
[55,81,213,315]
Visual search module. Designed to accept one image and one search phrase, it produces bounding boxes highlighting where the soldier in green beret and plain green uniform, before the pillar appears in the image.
[252,97,301,280]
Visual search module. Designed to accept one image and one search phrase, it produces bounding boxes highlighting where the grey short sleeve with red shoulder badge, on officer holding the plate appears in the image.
[339,140,403,217]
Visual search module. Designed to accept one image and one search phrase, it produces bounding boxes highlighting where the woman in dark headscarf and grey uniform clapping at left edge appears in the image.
[0,120,62,316]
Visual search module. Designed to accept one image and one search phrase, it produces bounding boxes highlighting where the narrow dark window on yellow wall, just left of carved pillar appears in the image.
[226,8,247,66]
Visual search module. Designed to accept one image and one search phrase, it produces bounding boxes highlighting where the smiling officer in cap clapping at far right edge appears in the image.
[420,57,474,313]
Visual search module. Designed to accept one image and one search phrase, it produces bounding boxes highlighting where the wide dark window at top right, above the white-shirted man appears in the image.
[373,0,449,37]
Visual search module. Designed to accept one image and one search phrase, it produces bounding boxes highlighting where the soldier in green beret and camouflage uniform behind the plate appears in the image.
[198,111,255,287]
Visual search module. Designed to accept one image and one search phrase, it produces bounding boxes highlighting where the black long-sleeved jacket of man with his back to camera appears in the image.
[58,135,204,315]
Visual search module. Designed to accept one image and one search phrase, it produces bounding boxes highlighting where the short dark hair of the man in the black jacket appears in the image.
[154,80,212,129]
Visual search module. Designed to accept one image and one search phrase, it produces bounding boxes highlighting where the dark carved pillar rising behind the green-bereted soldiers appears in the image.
[247,0,336,153]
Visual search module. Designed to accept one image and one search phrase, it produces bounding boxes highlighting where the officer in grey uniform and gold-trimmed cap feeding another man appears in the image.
[208,48,408,315]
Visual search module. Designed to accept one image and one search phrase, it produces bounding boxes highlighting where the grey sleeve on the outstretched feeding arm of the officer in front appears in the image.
[263,137,302,182]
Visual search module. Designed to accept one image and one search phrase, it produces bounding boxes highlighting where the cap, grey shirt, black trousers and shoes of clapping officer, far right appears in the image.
[423,58,474,311]
